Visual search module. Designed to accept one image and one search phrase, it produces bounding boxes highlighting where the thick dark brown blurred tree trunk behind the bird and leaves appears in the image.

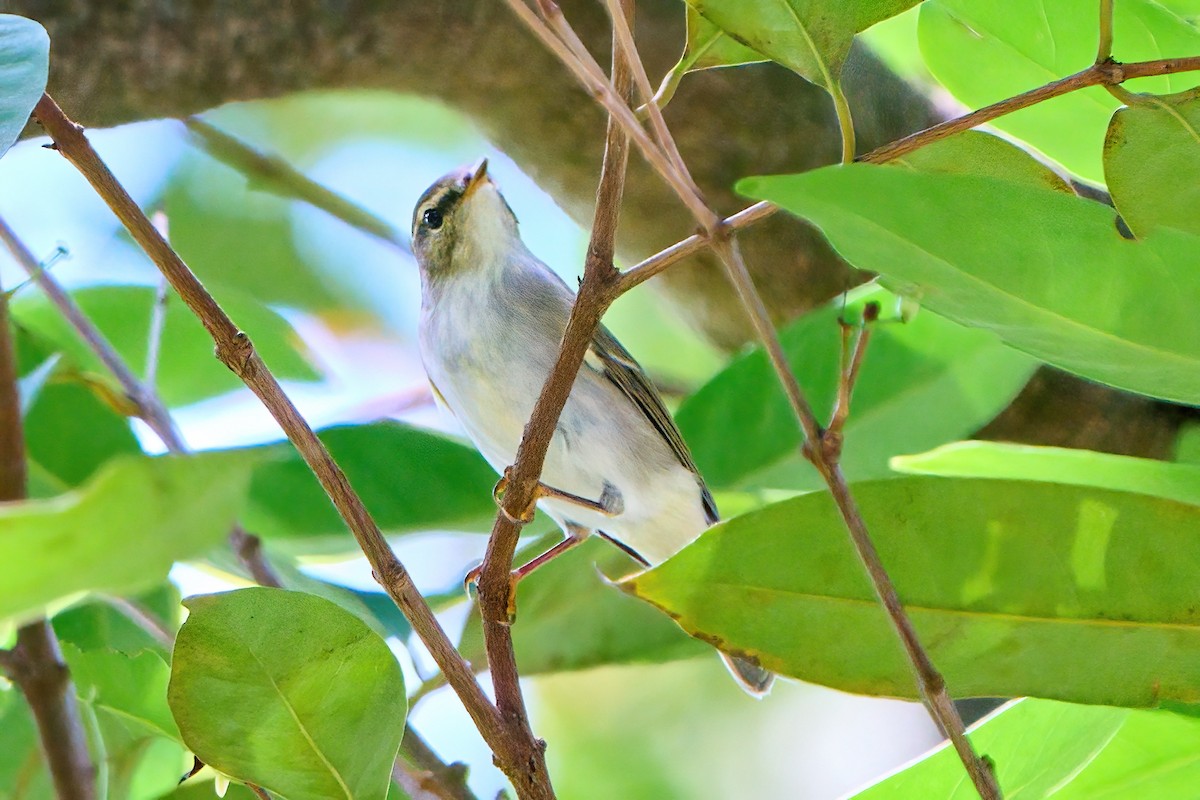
[7,0,1178,456]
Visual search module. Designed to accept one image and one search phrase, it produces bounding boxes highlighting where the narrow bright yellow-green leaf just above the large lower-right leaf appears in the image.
[892,441,1200,505]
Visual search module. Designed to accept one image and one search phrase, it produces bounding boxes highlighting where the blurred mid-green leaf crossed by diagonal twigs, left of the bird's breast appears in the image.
[12,285,319,407]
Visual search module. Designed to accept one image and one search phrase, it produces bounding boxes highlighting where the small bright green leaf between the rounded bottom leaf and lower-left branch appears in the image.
[62,644,182,743]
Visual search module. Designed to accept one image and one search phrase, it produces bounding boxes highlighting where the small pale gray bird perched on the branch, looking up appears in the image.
[413,160,774,694]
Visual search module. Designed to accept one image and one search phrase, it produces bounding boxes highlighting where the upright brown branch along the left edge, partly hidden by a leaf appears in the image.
[0,245,96,800]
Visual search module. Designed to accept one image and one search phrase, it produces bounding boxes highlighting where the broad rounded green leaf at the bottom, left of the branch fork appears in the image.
[168,588,407,800]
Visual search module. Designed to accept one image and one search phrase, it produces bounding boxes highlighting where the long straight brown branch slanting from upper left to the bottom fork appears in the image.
[27,95,548,796]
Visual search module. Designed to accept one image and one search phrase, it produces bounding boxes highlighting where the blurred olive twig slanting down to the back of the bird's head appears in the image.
[184,116,410,253]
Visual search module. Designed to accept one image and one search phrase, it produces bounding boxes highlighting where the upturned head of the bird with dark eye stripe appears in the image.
[413,158,520,279]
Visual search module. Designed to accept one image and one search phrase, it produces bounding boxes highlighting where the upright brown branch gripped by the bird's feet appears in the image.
[479,7,630,798]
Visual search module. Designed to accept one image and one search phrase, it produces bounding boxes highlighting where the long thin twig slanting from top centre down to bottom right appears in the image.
[506,0,1001,800]
